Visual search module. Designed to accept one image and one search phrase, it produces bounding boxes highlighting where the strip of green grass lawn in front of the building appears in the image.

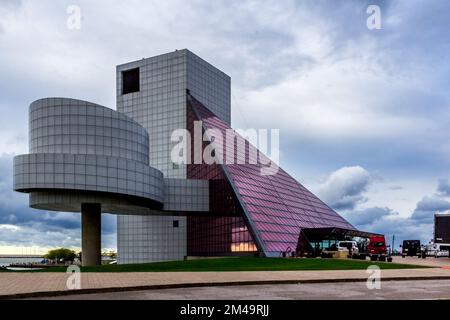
[4,257,424,272]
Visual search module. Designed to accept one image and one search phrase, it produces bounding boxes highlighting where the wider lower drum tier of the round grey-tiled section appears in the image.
[14,153,163,210]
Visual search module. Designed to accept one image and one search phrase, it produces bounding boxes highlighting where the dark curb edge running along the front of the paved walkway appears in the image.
[0,276,450,300]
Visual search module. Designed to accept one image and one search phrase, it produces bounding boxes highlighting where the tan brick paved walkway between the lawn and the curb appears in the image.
[0,268,450,298]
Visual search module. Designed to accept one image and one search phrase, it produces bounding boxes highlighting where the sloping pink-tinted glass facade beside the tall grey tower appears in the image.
[187,96,356,256]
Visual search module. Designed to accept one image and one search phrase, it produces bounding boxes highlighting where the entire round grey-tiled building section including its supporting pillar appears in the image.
[14,98,164,266]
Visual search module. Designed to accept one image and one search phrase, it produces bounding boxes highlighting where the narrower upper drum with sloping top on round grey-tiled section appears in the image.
[29,98,149,165]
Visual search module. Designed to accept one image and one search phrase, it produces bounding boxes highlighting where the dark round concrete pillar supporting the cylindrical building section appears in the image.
[81,203,102,266]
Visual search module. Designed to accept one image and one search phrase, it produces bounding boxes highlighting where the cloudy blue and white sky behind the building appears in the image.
[0,0,450,253]
